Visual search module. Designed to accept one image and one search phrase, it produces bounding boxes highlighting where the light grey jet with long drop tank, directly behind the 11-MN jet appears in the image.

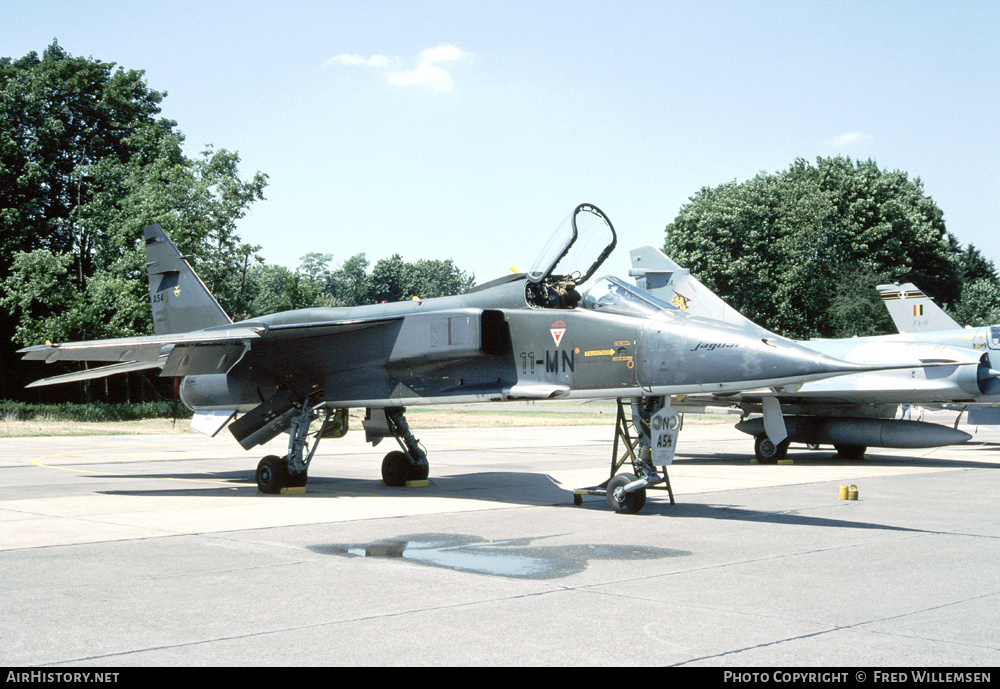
[630,246,1000,460]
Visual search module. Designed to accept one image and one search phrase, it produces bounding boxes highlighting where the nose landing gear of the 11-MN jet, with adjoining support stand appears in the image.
[573,398,680,514]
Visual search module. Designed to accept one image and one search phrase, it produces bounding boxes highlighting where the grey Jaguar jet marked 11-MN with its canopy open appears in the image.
[21,204,952,512]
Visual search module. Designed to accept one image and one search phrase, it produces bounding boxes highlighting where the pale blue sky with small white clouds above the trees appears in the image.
[0,0,1000,281]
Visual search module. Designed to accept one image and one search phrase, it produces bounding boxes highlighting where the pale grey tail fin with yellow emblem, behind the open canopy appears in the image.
[629,245,760,330]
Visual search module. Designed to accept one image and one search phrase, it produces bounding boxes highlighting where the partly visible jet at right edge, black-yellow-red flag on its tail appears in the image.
[876,282,1000,426]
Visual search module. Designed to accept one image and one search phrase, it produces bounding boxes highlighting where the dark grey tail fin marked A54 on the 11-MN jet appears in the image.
[143,225,233,335]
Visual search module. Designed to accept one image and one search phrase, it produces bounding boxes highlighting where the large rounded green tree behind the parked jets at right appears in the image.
[664,156,960,338]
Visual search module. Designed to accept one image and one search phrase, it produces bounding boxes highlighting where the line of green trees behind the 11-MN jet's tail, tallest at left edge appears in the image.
[0,41,473,399]
